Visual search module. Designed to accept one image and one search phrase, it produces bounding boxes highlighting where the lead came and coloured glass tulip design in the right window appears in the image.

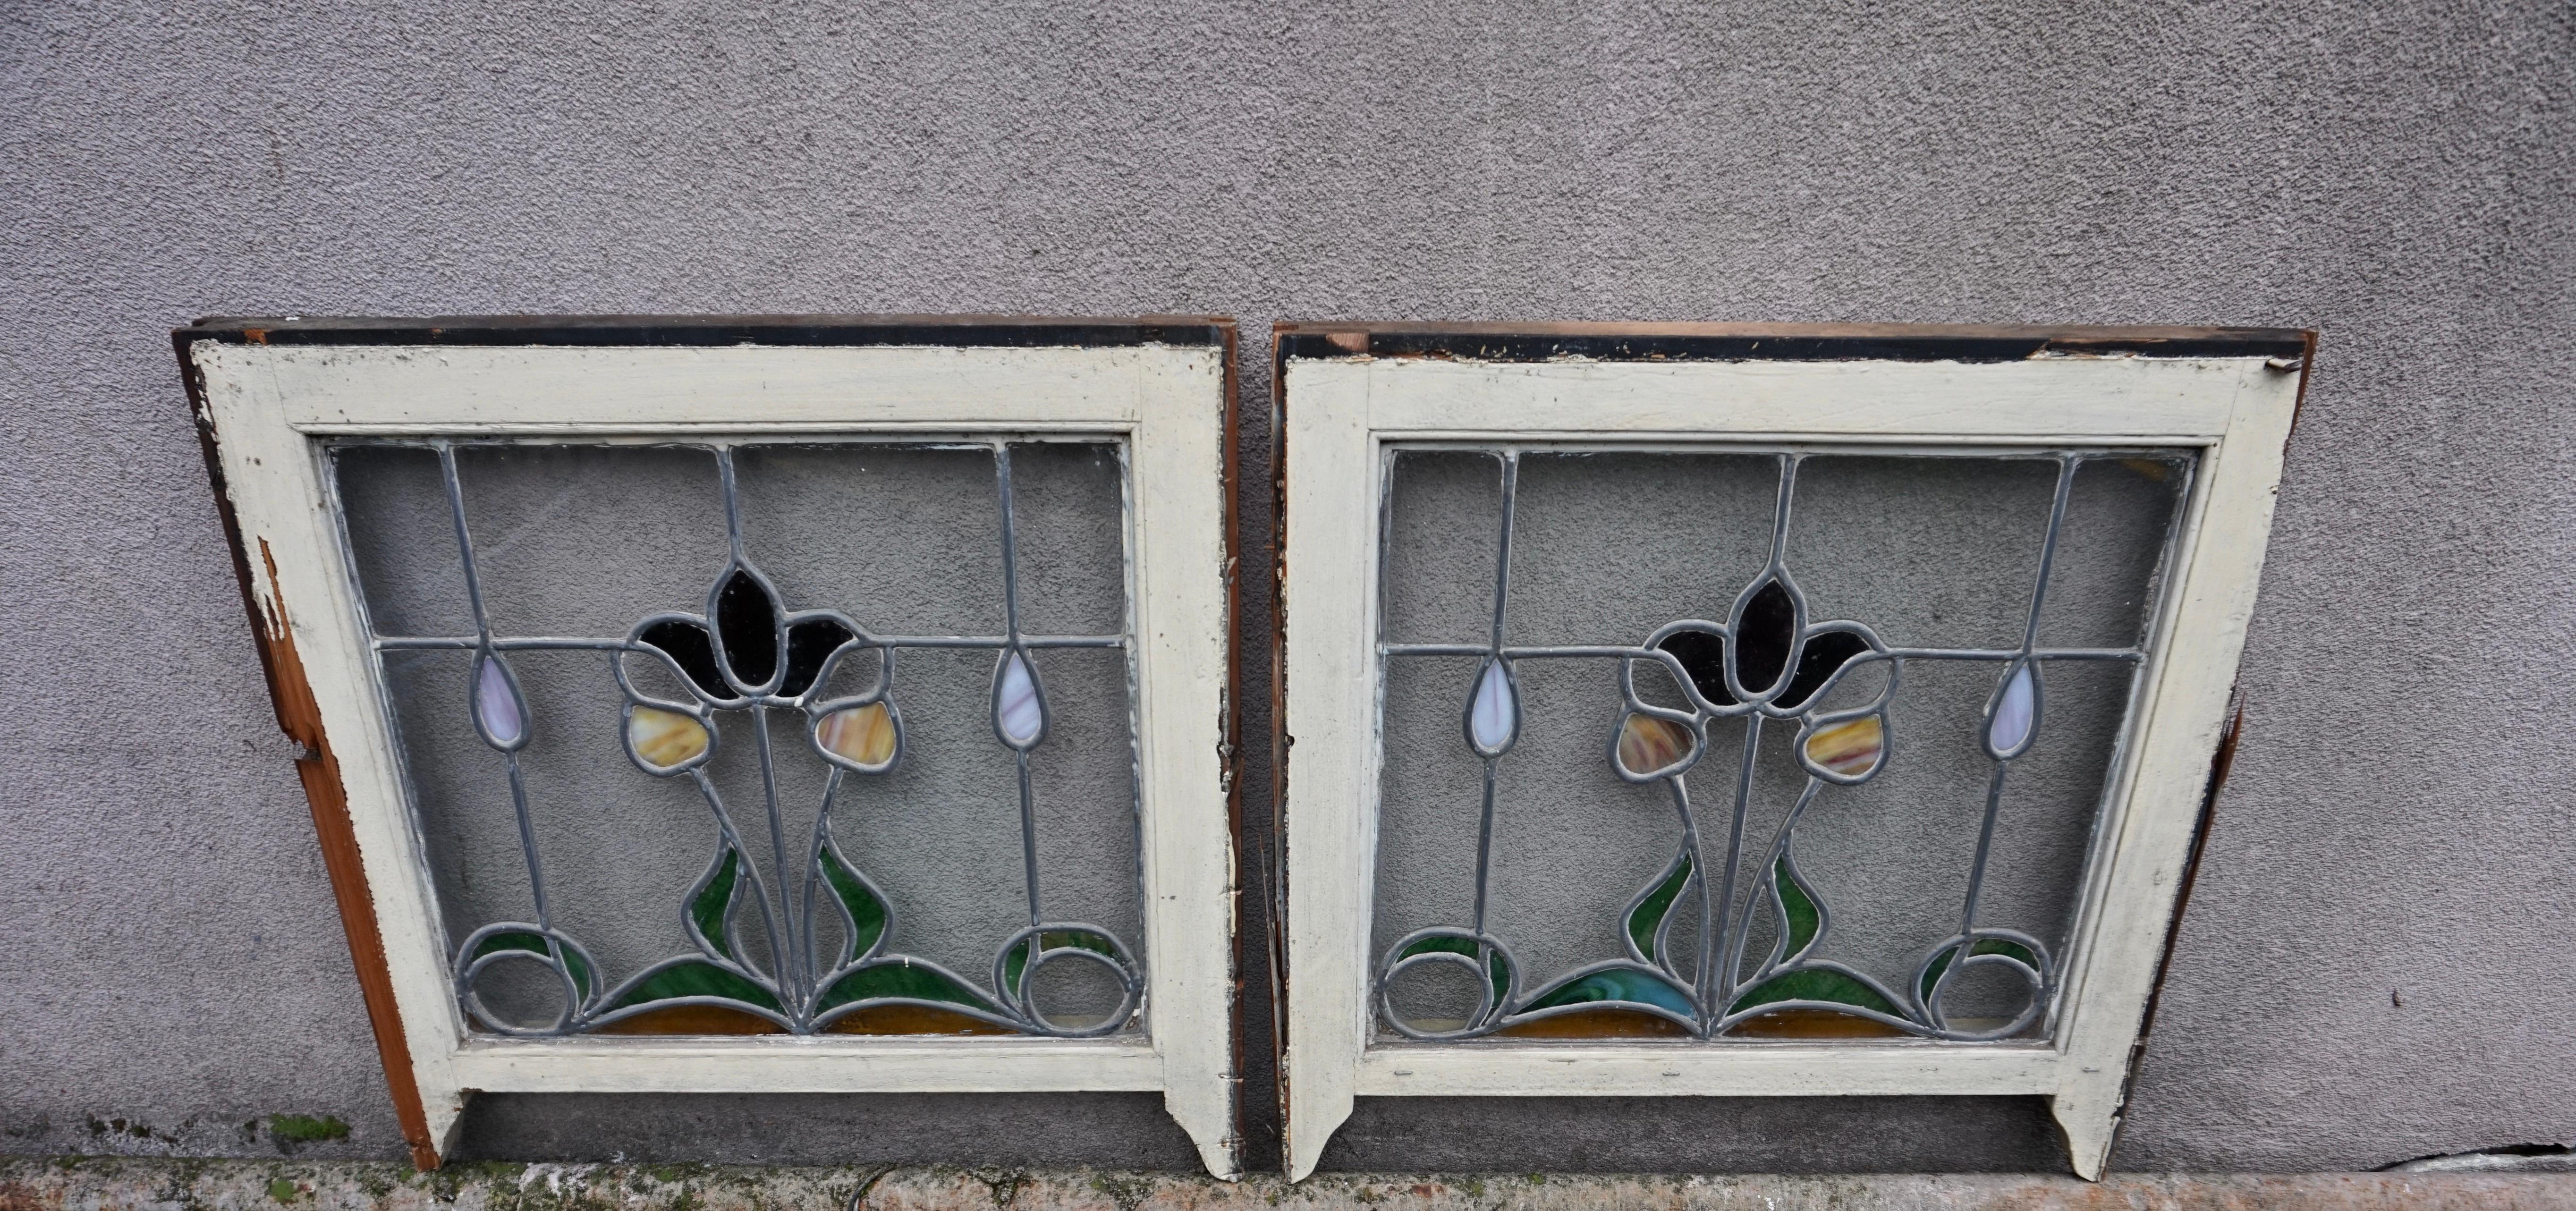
[1373,446,2177,1041]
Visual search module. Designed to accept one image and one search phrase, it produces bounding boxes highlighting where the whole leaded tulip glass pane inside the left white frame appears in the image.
[330,438,1144,1036]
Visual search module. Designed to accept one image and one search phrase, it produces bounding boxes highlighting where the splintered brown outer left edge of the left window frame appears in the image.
[170,330,441,1170]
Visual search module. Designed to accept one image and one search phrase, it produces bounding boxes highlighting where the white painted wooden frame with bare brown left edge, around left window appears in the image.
[175,317,1242,1177]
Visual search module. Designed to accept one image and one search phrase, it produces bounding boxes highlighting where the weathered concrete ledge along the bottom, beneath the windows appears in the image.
[0,1157,2576,1211]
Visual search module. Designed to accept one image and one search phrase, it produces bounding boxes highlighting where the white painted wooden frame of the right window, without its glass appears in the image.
[1278,325,2313,1180]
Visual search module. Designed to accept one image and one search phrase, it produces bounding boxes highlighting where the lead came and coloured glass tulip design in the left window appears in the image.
[371,438,1144,1038]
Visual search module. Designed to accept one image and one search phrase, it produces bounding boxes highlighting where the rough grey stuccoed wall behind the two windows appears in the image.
[0,0,2576,1170]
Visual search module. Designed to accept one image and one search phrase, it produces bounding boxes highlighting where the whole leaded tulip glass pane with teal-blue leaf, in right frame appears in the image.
[1371,443,2195,1043]
